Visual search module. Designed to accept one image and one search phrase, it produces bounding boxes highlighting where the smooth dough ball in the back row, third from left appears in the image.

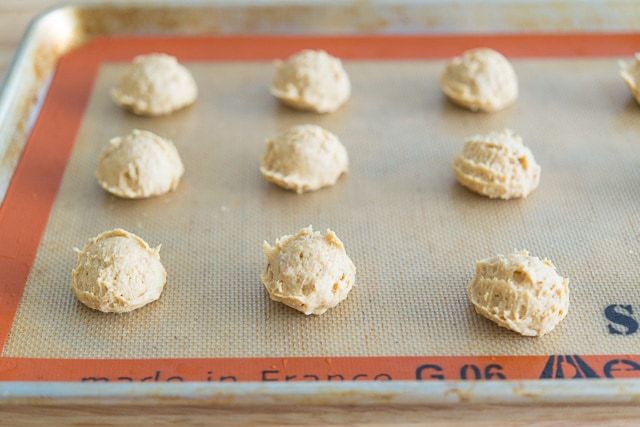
[440,48,518,112]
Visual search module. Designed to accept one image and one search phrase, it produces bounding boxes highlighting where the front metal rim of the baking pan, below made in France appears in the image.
[0,379,640,408]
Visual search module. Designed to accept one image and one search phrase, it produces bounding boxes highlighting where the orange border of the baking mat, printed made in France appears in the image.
[0,33,640,381]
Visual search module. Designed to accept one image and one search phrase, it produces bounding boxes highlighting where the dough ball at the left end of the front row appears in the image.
[71,229,167,313]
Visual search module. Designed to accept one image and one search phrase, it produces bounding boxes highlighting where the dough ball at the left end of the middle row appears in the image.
[96,129,184,199]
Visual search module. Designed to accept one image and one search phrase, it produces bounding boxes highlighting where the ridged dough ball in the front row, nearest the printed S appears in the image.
[468,251,569,336]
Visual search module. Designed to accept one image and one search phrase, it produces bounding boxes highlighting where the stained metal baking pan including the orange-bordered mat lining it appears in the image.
[0,1,640,423]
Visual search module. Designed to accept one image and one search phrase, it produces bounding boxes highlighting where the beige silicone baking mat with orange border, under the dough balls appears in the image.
[0,35,640,381]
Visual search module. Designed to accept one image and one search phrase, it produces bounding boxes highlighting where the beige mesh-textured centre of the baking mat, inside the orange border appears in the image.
[3,59,640,358]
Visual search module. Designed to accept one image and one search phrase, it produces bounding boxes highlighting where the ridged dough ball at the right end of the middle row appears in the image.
[453,129,541,199]
